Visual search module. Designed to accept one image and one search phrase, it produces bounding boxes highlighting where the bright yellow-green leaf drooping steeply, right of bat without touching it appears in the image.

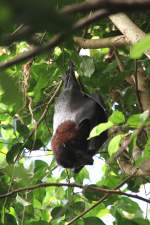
[108,134,124,156]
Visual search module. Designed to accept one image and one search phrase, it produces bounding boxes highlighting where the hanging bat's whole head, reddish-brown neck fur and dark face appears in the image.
[52,120,93,168]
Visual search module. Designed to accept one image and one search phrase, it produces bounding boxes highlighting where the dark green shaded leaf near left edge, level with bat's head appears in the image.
[6,143,24,164]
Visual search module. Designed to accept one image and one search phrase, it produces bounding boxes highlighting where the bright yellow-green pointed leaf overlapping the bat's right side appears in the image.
[88,121,113,139]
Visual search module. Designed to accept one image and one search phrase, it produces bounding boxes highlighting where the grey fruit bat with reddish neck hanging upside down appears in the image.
[51,63,107,173]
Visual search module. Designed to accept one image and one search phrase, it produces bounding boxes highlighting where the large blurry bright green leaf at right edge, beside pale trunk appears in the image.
[130,34,150,59]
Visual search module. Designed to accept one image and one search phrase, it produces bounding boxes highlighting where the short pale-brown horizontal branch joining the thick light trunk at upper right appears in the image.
[73,35,129,49]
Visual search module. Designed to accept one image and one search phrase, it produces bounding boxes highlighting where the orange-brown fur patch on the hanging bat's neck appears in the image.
[51,120,78,152]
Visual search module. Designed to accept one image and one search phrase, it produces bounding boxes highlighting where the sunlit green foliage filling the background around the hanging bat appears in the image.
[0,0,150,225]
